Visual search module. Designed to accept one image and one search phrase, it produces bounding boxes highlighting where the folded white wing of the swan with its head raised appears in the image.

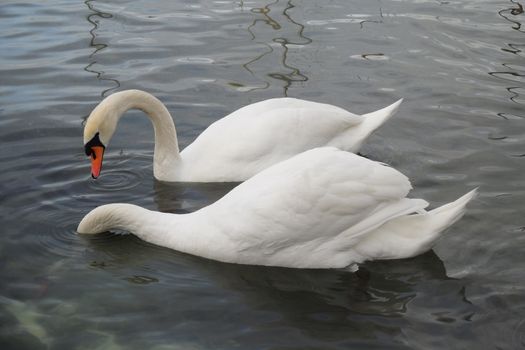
[181,98,363,181]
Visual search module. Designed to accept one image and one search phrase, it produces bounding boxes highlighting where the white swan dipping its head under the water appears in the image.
[77,147,476,268]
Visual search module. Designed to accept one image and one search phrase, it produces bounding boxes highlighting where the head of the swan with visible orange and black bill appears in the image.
[84,94,123,179]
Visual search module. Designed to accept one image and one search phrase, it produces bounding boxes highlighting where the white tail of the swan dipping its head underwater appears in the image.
[356,188,477,260]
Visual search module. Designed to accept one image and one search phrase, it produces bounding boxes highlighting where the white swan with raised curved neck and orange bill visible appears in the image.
[84,90,402,182]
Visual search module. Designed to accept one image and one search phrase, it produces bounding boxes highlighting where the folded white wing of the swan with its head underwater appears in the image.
[206,147,423,266]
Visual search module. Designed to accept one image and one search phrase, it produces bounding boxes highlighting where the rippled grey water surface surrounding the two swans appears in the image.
[0,0,525,350]
